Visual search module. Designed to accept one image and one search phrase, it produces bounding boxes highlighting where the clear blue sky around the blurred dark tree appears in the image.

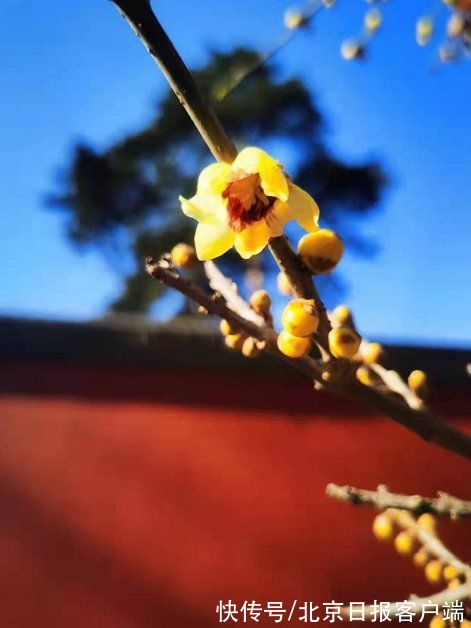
[0,0,471,346]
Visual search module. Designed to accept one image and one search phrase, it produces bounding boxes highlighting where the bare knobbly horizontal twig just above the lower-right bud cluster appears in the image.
[326,483,471,519]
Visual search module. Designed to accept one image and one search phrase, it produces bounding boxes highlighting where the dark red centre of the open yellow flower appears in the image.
[222,172,276,231]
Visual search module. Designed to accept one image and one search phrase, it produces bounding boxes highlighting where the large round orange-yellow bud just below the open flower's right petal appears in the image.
[298,229,343,275]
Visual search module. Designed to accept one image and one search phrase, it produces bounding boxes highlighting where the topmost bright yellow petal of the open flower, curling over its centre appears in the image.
[232,146,289,201]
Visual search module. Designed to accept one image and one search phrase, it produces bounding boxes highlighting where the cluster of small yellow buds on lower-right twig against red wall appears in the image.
[373,509,464,628]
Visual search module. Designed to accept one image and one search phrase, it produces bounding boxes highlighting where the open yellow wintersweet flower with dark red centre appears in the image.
[180,147,319,260]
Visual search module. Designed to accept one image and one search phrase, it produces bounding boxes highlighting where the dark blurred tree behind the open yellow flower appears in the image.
[49,48,385,312]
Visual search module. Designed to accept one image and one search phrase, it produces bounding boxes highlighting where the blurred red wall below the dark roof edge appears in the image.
[0,362,471,628]
